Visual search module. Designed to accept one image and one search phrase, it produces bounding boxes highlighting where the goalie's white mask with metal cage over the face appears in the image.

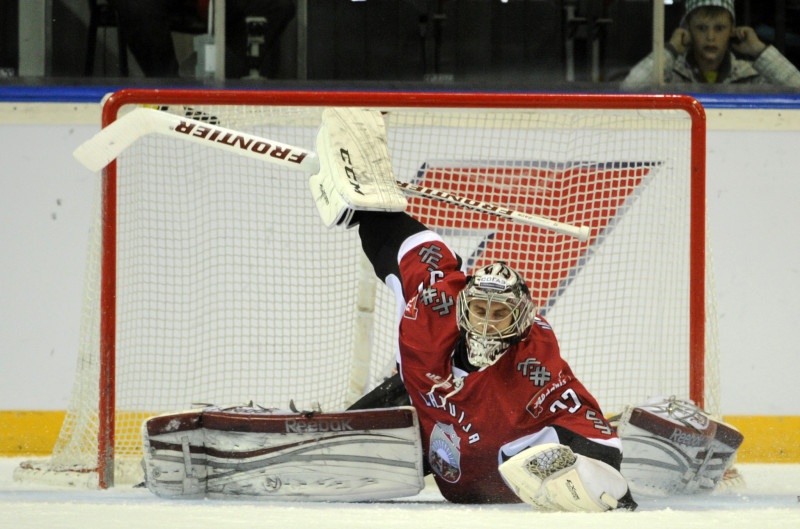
[456,261,536,367]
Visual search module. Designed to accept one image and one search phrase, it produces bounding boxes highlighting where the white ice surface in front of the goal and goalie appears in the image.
[0,458,800,529]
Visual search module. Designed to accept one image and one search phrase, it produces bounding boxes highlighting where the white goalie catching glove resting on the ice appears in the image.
[499,443,635,512]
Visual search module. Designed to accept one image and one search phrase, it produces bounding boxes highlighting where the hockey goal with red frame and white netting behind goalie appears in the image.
[15,89,719,488]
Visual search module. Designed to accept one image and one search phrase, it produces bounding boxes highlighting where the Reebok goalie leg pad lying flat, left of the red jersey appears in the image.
[142,405,424,501]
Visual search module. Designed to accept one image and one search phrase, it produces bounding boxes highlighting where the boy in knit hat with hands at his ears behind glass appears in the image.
[622,0,800,89]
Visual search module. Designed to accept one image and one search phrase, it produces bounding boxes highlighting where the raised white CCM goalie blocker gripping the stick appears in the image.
[309,107,408,228]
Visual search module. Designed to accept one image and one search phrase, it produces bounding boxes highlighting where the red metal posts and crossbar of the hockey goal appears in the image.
[67,89,706,488]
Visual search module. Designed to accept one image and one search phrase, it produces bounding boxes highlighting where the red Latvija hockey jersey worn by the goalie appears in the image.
[398,231,616,503]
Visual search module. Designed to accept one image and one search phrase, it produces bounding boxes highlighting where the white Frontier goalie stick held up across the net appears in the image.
[73,108,589,241]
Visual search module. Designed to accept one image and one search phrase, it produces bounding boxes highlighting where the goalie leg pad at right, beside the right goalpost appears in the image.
[612,397,744,496]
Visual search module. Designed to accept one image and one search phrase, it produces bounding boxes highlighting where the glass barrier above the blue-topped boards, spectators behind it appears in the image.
[0,0,800,94]
